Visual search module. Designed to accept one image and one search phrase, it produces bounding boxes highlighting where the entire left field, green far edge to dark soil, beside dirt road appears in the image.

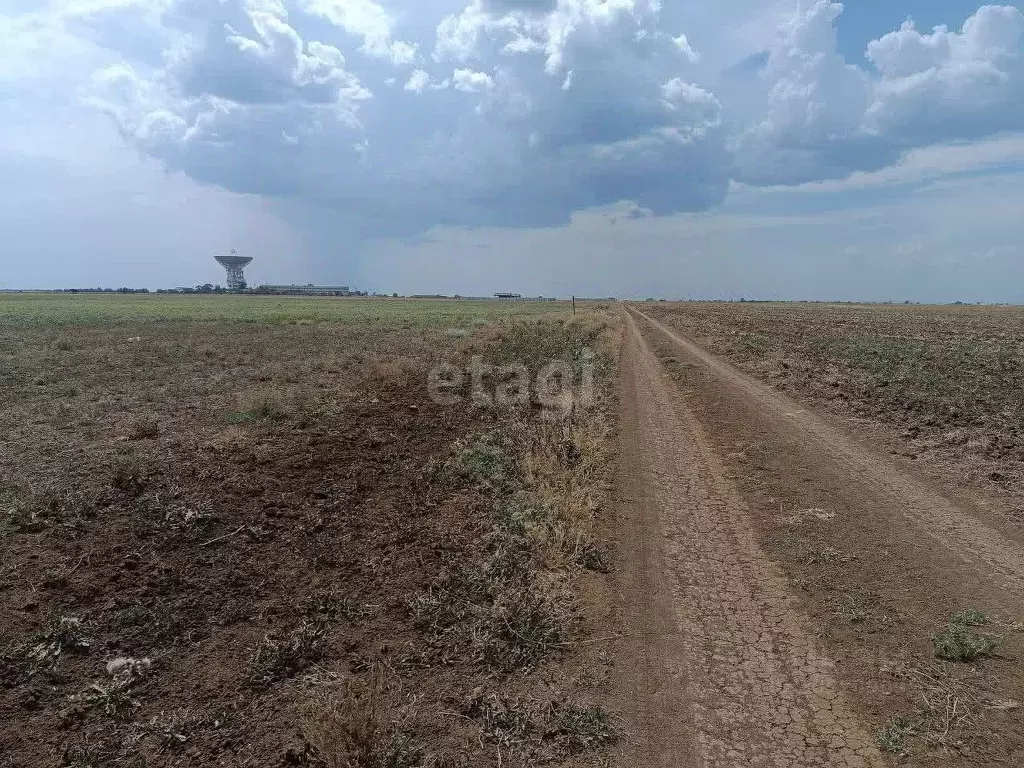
[0,295,617,768]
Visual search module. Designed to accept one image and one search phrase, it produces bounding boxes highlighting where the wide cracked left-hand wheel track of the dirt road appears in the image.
[620,313,885,768]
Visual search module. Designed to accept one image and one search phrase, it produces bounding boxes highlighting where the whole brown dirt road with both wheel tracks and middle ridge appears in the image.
[617,308,1024,768]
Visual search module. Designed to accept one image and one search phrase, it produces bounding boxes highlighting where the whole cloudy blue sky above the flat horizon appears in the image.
[0,0,1024,302]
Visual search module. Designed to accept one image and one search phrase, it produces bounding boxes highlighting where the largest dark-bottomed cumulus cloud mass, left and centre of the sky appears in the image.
[75,0,728,233]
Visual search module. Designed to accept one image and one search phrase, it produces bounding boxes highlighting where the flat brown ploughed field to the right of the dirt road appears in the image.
[638,303,1024,494]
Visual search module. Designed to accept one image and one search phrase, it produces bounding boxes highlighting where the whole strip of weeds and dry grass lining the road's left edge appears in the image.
[410,317,617,745]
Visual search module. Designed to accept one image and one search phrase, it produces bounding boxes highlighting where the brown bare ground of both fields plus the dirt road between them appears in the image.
[9,305,1024,768]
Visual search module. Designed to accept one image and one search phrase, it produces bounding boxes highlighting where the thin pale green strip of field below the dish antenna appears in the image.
[0,293,571,328]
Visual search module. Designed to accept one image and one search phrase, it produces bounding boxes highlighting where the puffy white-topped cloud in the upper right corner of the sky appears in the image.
[735,0,1024,184]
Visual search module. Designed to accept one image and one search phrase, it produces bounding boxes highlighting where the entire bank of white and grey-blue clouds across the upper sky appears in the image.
[8,0,1024,243]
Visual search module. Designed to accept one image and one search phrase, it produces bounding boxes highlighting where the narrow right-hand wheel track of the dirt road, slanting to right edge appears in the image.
[629,307,1024,598]
